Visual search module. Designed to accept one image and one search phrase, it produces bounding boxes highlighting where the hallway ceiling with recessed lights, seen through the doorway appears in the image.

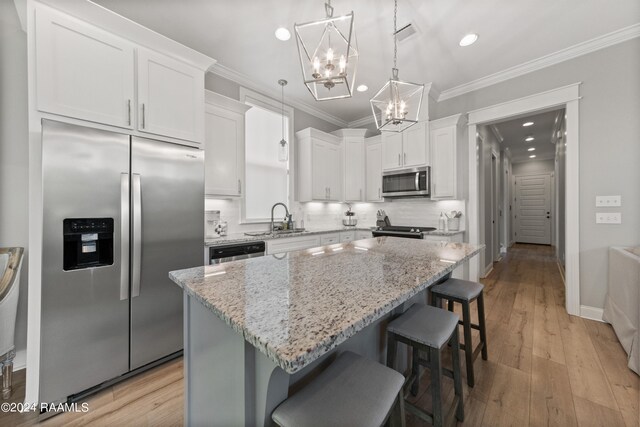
[490,109,564,163]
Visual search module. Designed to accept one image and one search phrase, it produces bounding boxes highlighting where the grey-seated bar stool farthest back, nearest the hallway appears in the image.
[430,279,487,387]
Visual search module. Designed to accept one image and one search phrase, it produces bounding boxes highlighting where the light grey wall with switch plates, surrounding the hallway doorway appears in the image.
[430,38,640,308]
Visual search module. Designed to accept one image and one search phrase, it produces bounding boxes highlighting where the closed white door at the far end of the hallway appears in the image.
[514,174,551,245]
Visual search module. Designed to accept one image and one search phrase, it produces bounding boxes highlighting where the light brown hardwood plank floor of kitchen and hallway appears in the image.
[0,244,640,427]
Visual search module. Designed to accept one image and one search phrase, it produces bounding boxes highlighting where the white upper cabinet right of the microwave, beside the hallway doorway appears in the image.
[430,114,466,200]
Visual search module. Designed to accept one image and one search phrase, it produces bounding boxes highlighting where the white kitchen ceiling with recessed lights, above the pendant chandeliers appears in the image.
[93,0,640,122]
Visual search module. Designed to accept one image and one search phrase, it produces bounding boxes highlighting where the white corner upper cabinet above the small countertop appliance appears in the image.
[332,129,367,202]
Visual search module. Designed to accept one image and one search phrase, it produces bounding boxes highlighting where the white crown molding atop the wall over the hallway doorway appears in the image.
[438,24,640,102]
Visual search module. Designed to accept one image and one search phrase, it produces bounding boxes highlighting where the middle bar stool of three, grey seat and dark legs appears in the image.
[387,304,464,426]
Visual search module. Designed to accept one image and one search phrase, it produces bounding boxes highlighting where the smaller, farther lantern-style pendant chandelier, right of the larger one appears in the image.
[370,0,424,132]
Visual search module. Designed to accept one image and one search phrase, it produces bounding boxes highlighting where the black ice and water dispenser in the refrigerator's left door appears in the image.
[63,218,113,271]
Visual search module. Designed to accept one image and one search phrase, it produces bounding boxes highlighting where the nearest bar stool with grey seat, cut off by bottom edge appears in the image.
[271,351,405,427]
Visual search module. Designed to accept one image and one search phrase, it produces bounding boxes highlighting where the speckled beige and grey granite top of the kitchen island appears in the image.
[169,237,482,373]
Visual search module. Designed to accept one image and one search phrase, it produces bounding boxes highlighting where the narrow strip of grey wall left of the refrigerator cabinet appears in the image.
[0,0,29,368]
